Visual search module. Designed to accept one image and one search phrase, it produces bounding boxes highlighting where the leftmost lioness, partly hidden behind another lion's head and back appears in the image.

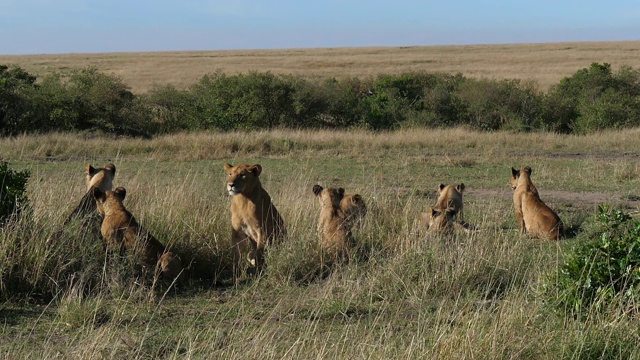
[64,164,116,228]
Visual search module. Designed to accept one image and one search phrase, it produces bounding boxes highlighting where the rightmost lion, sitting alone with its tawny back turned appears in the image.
[509,166,563,240]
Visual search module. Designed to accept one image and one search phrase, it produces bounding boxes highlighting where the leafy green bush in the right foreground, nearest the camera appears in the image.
[546,206,640,315]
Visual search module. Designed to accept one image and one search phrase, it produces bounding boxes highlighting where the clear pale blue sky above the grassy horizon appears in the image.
[0,0,640,55]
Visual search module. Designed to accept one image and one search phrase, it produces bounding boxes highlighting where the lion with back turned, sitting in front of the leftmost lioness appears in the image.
[91,186,182,280]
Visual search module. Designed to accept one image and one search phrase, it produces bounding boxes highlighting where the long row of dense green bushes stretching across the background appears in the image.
[0,63,640,137]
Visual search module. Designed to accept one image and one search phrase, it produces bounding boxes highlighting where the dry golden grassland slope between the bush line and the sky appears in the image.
[0,41,640,93]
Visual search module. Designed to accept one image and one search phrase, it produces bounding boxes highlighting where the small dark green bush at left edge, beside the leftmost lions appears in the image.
[0,161,30,225]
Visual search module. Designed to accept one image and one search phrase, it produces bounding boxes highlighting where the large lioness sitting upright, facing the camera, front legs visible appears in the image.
[224,163,286,280]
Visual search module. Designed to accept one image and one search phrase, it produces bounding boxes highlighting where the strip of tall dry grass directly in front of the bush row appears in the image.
[0,128,640,161]
